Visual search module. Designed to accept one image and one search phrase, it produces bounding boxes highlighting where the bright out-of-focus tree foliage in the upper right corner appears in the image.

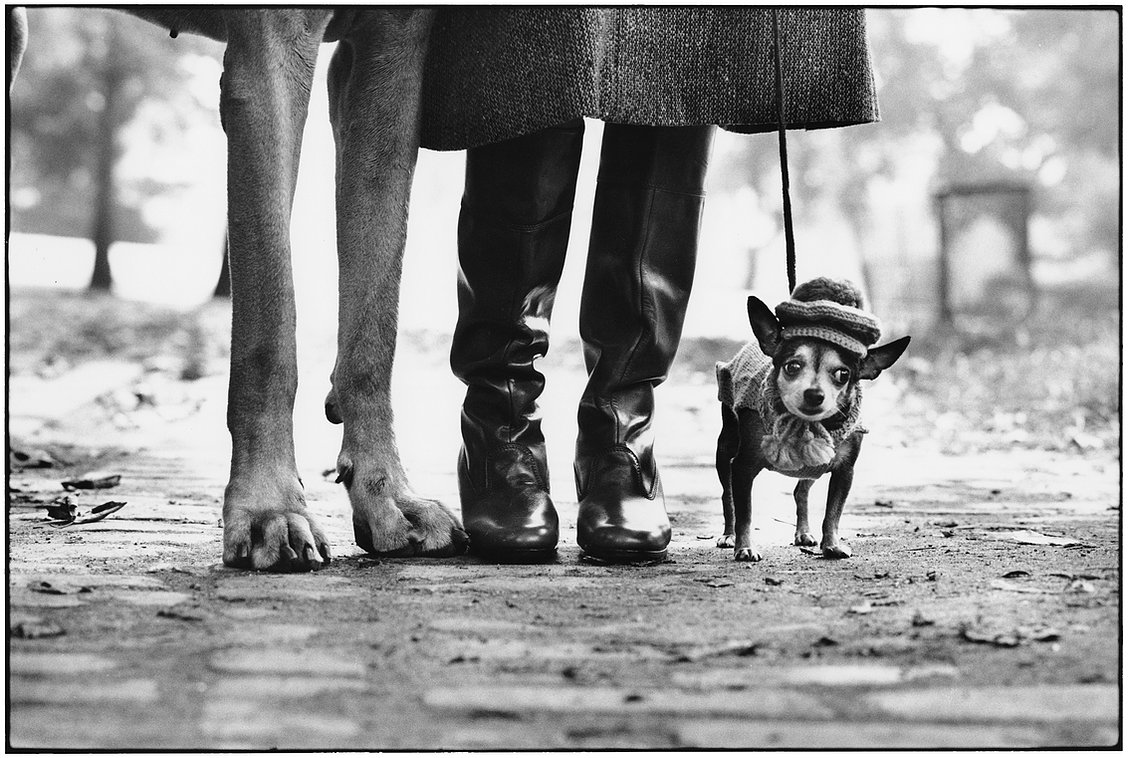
[844,9,1120,259]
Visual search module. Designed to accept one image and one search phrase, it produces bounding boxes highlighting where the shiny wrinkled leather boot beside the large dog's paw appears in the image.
[450,120,583,561]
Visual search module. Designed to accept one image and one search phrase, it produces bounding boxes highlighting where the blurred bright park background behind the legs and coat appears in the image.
[9,8,1121,450]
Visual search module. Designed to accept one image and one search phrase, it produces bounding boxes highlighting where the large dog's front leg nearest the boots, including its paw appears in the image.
[326,8,467,556]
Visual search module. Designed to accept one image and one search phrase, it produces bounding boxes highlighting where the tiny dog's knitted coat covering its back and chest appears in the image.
[716,342,866,479]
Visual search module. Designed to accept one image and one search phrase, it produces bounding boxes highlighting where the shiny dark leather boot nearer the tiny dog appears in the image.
[575,124,714,563]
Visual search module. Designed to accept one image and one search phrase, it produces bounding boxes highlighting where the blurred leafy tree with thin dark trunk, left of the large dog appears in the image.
[11,8,218,290]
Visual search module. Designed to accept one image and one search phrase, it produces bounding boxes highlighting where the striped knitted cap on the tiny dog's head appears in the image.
[776,276,881,358]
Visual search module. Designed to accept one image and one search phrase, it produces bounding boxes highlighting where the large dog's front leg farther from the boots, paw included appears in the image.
[220,9,331,571]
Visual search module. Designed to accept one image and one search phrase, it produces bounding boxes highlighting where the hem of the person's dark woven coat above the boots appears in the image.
[421,6,878,150]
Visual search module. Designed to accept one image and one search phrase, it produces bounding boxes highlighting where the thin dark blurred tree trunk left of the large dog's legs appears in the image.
[89,24,124,292]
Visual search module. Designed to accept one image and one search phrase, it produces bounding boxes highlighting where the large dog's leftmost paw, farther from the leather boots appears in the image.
[223,477,332,572]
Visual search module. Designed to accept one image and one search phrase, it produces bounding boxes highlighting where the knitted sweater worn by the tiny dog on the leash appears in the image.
[716,342,866,479]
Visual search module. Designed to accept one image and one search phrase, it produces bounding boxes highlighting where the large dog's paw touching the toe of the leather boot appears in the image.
[342,462,469,557]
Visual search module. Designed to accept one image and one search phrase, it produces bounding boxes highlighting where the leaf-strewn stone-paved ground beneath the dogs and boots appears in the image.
[8,329,1121,749]
